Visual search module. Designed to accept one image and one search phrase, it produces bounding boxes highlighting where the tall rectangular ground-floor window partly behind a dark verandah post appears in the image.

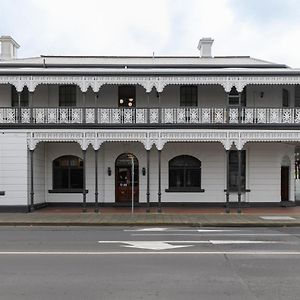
[229,150,246,191]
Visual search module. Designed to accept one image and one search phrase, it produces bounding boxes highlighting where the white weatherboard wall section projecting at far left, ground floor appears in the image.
[0,132,28,205]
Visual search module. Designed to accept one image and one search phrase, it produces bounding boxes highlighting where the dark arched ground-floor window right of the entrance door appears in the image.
[169,155,201,191]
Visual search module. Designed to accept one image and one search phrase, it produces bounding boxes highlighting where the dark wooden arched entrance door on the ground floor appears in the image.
[115,153,139,203]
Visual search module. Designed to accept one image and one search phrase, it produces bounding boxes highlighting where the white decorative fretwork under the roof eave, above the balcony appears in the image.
[0,75,300,93]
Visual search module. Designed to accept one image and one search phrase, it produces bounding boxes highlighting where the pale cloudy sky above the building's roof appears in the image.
[0,0,300,67]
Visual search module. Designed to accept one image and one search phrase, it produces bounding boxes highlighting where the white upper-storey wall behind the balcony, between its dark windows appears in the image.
[0,84,295,107]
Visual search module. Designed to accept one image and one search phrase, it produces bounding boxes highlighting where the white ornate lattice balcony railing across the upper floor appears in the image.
[0,107,300,125]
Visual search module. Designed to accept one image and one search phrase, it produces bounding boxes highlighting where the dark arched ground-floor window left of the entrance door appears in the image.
[53,155,83,190]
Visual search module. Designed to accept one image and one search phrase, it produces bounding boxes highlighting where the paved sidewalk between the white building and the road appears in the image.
[0,207,300,227]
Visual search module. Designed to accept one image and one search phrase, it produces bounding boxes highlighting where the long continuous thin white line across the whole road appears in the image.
[0,251,300,256]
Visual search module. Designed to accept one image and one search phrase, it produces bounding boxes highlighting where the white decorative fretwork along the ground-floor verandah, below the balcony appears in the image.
[27,129,300,150]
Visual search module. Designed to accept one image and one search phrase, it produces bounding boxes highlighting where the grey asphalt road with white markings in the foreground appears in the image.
[0,227,300,300]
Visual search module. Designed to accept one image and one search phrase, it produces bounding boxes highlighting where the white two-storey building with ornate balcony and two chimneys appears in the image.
[0,36,300,211]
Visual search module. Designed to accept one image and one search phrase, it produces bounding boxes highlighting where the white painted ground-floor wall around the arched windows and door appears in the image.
[0,133,294,205]
